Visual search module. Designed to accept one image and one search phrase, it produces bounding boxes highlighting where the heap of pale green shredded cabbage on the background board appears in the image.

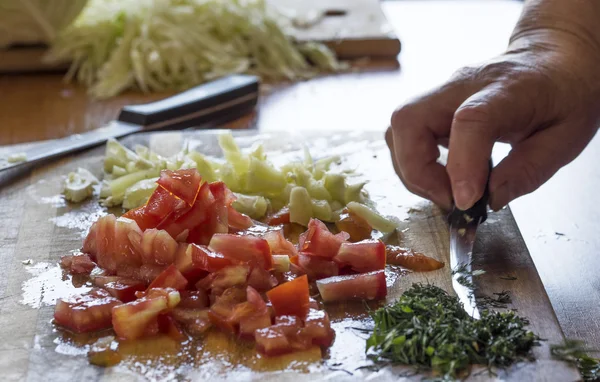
[46,0,346,98]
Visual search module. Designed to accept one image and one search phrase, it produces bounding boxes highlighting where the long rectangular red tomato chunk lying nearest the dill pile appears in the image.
[317,271,387,302]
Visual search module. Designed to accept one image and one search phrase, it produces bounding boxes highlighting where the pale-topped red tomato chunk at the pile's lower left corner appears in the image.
[54,288,121,333]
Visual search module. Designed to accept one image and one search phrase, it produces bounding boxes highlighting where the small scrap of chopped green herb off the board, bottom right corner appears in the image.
[550,340,600,381]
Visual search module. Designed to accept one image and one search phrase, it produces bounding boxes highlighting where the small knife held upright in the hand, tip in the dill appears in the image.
[448,159,492,319]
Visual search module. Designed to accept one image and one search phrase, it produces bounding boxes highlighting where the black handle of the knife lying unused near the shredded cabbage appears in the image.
[118,74,259,130]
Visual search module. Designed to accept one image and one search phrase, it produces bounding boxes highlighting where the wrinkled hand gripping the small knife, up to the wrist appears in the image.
[385,16,600,210]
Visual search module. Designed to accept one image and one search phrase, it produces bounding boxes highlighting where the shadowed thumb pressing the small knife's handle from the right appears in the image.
[490,118,596,211]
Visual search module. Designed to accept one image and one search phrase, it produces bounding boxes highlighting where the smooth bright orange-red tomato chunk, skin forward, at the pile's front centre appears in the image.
[267,275,309,317]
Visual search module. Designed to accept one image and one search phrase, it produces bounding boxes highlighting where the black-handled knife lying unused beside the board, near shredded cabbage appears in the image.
[0,74,259,172]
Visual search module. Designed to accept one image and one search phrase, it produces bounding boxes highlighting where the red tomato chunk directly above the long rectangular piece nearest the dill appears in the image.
[334,240,385,273]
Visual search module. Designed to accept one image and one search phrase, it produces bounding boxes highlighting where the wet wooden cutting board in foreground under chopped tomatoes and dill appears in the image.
[0,131,578,382]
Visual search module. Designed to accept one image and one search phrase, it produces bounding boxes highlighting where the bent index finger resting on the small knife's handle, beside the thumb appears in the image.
[446,84,531,210]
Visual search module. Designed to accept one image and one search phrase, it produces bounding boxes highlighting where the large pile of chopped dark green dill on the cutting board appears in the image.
[367,284,539,379]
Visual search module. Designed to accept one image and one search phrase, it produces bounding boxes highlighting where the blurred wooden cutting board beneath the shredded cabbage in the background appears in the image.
[0,0,400,73]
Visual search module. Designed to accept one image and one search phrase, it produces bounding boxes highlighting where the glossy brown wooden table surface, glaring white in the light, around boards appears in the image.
[0,0,600,348]
